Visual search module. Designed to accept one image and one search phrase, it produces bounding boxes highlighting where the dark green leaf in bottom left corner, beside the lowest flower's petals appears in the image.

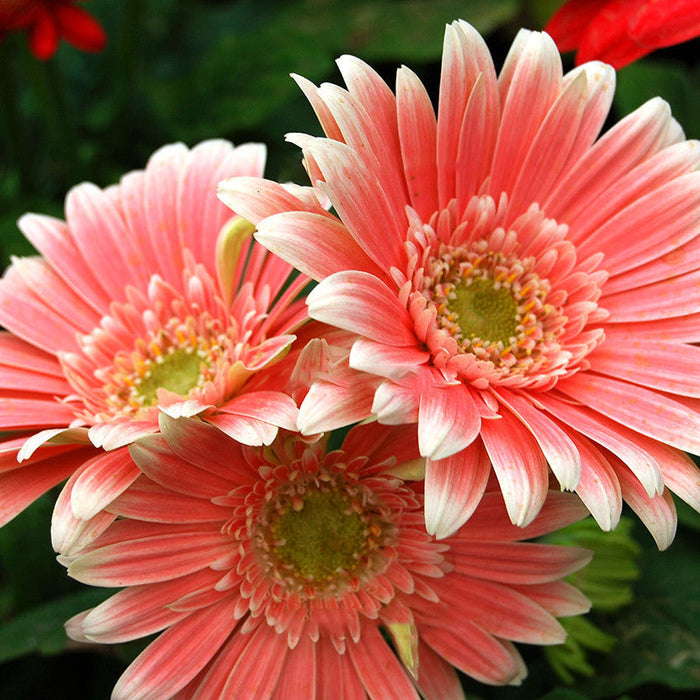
[0,589,114,662]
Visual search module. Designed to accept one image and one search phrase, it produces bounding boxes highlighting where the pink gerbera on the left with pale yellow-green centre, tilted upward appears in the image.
[0,141,306,522]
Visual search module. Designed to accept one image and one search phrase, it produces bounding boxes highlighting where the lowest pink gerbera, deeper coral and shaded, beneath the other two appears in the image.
[60,415,590,700]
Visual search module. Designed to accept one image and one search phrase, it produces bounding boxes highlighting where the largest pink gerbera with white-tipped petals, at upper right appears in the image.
[220,21,700,547]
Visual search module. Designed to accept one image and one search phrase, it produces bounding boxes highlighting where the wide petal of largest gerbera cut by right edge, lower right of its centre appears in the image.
[557,372,700,456]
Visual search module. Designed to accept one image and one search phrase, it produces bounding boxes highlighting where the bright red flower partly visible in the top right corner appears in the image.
[544,0,700,68]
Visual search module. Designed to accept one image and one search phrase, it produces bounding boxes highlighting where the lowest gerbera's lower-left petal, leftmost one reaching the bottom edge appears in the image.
[112,599,236,700]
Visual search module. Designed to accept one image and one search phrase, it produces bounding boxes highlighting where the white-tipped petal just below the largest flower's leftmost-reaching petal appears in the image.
[255,211,383,280]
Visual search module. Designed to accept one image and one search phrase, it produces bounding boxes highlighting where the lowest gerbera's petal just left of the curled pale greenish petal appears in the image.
[346,624,418,700]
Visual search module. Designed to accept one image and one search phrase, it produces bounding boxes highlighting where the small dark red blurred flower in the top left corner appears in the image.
[0,0,107,61]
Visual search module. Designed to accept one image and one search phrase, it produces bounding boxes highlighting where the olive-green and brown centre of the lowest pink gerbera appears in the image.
[253,465,396,598]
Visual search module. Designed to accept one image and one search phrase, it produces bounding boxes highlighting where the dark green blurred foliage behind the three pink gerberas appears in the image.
[0,0,700,700]
